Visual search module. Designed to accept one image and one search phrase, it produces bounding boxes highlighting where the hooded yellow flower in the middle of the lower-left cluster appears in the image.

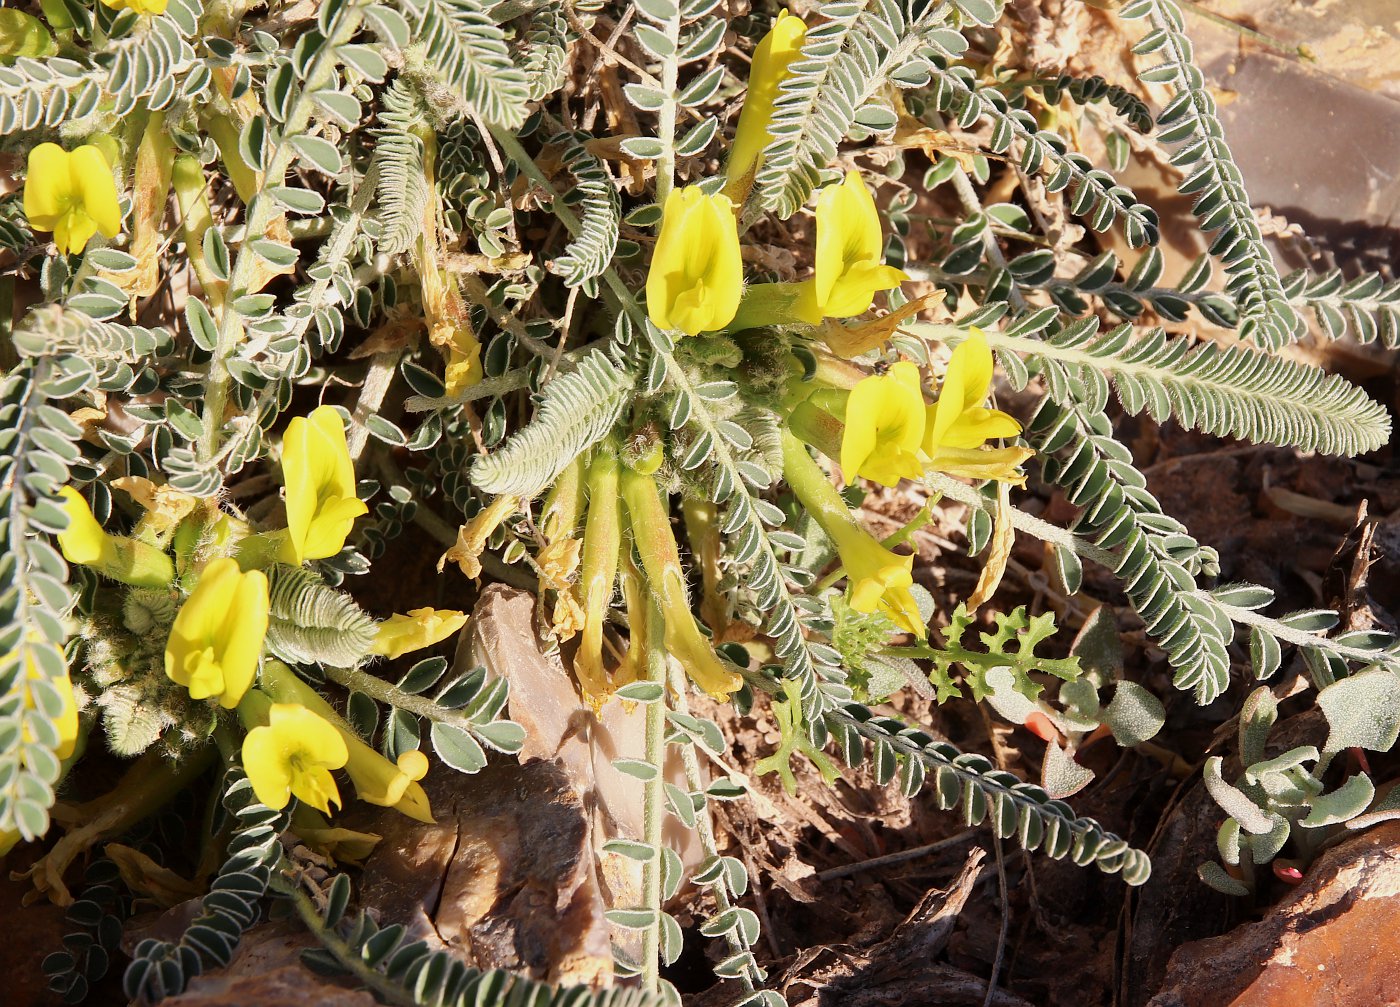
[165,556,267,710]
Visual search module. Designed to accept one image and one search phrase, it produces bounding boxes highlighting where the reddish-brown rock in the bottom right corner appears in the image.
[1149,822,1400,1007]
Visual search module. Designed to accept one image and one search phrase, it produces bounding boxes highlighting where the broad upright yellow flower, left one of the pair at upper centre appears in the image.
[647,185,743,336]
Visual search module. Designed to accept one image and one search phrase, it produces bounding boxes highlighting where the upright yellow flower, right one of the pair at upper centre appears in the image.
[812,171,909,325]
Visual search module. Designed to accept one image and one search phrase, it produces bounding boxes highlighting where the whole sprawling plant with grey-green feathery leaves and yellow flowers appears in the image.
[0,0,1400,1004]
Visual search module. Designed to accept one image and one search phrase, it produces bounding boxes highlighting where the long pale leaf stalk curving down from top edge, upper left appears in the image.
[199,3,368,461]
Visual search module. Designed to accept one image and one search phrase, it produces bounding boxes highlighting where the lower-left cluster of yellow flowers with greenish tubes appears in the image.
[45,406,466,840]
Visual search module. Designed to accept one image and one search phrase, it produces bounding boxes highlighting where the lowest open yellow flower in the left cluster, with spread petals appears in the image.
[244,705,350,814]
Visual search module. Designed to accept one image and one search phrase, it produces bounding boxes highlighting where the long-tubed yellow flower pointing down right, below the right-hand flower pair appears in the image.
[783,430,928,640]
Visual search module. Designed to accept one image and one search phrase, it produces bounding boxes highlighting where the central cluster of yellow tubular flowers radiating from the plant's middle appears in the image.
[613,13,1030,672]
